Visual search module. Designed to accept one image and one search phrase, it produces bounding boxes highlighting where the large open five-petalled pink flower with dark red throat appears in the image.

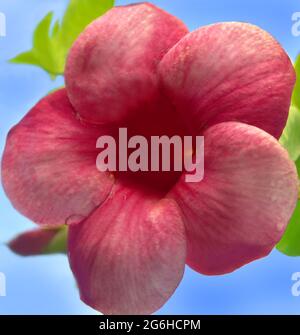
[2,4,297,314]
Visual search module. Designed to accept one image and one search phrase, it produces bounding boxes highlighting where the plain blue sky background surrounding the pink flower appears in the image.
[0,0,300,314]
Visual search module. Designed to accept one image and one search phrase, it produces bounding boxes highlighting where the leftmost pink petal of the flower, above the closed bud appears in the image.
[2,89,113,225]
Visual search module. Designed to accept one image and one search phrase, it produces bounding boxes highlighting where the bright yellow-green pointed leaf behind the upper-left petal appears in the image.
[10,0,114,78]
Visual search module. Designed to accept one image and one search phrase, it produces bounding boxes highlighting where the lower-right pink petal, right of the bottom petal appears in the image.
[170,122,297,274]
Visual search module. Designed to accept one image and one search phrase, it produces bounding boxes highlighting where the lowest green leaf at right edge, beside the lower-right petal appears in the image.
[276,201,300,256]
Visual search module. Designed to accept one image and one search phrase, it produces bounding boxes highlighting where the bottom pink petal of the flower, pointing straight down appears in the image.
[69,186,186,314]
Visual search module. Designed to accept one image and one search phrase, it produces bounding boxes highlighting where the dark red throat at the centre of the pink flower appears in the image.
[104,94,188,194]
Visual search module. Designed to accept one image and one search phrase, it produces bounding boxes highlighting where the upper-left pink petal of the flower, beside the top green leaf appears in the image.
[65,3,188,123]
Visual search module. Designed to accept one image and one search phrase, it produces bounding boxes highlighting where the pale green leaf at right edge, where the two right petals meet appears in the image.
[279,105,300,161]
